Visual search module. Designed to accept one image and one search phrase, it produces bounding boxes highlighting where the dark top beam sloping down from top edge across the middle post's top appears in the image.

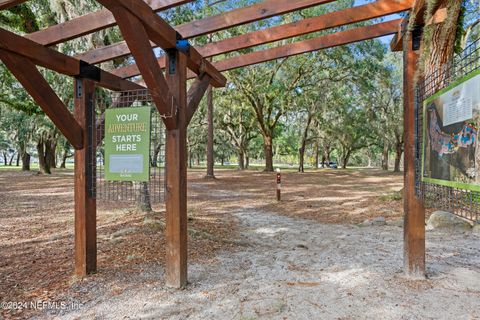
[98,0,227,87]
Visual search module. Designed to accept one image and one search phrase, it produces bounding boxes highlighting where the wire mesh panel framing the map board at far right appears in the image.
[415,40,480,222]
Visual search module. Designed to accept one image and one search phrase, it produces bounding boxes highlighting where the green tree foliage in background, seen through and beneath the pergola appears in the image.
[0,0,406,171]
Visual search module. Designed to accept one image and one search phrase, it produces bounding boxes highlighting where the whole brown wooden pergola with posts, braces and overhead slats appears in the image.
[0,0,432,287]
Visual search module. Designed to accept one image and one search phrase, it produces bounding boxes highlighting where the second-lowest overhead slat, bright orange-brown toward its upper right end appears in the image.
[112,0,413,78]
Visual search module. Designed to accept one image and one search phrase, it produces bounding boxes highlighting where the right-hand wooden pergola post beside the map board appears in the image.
[403,33,425,277]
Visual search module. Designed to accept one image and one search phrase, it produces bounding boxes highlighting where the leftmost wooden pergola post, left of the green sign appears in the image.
[74,78,97,277]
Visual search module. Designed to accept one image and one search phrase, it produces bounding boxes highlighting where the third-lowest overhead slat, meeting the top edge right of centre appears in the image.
[77,0,335,64]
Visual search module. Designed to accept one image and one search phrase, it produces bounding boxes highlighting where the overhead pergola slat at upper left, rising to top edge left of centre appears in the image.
[25,0,193,46]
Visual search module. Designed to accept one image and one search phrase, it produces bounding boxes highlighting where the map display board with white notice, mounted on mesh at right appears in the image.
[422,70,480,191]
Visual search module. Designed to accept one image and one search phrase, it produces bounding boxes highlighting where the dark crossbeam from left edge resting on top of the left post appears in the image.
[0,28,144,91]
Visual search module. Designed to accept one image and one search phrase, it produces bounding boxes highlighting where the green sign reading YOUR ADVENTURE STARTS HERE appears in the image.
[105,107,151,182]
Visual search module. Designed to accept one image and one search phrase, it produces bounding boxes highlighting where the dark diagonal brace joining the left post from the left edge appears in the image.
[0,49,83,149]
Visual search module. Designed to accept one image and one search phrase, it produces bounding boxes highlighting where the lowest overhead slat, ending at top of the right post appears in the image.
[210,19,401,74]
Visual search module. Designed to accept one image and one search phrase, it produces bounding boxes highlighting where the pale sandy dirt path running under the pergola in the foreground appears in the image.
[46,201,480,319]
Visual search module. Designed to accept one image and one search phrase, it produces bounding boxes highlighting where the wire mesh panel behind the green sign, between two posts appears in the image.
[91,90,165,204]
